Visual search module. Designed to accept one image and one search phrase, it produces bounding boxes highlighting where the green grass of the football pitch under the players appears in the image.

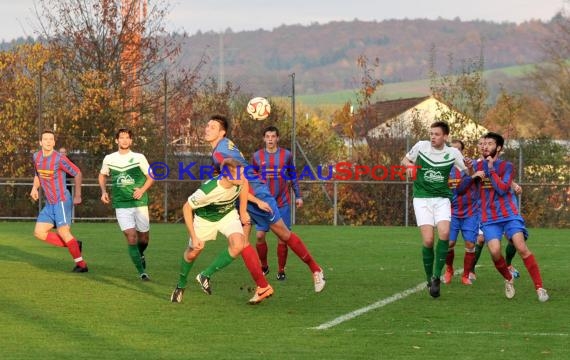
[0,222,570,360]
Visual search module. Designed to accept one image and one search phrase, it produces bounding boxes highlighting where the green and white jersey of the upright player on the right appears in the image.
[406,141,467,199]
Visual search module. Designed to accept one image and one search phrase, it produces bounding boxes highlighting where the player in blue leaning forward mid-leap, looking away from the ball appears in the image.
[204,115,325,292]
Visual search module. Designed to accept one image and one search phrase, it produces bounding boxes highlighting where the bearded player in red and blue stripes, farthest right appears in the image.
[466,132,549,302]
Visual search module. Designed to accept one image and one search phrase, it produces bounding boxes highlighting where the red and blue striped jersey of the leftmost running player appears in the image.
[33,150,81,204]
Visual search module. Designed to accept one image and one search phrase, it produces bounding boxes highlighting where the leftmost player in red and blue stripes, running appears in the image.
[30,130,88,273]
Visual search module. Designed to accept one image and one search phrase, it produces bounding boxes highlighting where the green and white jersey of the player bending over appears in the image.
[188,177,241,222]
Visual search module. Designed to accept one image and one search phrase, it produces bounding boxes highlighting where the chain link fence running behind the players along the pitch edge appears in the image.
[0,140,570,228]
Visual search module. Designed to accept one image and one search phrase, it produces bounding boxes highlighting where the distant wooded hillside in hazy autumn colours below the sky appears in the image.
[174,19,552,95]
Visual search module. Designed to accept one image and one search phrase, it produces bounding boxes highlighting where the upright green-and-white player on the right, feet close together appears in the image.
[402,121,466,298]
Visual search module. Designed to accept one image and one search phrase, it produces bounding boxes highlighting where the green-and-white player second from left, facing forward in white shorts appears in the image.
[99,129,154,281]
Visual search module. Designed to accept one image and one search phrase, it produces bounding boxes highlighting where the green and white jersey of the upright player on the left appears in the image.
[101,151,149,209]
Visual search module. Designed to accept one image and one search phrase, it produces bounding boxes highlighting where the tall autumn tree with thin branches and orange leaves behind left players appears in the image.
[31,0,179,163]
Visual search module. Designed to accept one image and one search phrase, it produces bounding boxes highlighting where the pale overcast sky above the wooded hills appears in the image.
[0,0,569,41]
